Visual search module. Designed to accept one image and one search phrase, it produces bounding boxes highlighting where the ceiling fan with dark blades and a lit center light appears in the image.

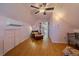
[31,3,54,15]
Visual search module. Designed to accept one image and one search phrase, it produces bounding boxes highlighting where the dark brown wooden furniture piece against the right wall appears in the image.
[67,32,79,50]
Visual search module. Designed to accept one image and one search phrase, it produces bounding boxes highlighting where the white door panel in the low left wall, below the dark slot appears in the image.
[4,30,14,54]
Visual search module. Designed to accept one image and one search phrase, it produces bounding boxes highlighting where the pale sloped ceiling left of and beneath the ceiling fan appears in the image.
[0,3,50,25]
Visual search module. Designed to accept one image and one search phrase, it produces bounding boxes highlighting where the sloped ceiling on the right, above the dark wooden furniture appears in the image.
[50,3,79,28]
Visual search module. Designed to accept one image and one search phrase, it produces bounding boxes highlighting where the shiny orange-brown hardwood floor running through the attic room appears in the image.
[5,38,66,56]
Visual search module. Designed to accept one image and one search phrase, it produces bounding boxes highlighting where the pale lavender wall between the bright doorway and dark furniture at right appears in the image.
[49,19,73,43]
